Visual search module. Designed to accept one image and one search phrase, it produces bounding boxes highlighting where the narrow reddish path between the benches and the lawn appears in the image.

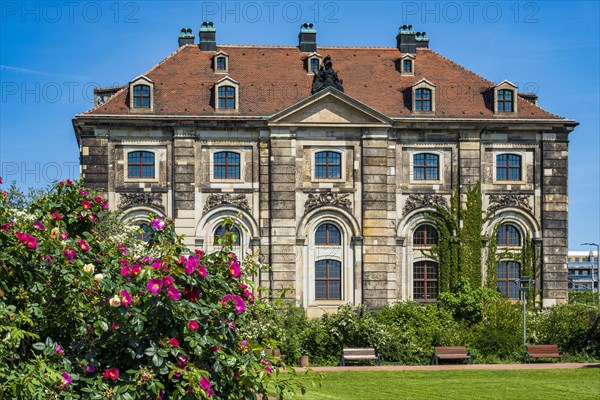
[294,362,600,372]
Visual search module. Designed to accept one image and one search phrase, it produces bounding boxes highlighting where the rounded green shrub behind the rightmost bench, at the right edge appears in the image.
[531,304,600,357]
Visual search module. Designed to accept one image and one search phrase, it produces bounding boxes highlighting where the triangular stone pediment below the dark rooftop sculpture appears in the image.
[269,88,391,126]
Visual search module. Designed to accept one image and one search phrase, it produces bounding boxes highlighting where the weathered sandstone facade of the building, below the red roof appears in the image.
[74,25,576,315]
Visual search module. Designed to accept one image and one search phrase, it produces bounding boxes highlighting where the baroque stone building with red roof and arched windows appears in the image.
[73,22,577,315]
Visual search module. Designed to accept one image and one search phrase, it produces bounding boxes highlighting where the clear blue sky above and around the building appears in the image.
[0,1,600,249]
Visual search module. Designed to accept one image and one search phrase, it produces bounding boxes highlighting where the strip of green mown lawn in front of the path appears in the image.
[295,368,600,400]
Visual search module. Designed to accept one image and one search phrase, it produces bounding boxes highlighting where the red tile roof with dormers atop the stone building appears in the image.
[84,45,562,119]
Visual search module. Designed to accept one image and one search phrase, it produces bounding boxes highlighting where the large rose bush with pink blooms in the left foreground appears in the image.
[0,180,297,400]
